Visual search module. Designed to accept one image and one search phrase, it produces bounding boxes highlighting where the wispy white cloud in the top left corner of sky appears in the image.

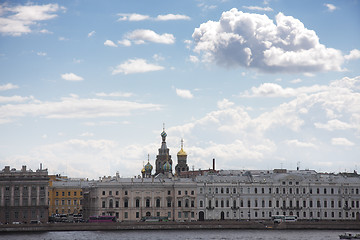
[0,3,65,36]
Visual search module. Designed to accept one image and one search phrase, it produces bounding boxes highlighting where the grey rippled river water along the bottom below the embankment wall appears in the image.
[0,230,352,240]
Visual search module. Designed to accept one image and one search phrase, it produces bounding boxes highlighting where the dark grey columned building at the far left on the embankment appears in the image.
[0,165,49,223]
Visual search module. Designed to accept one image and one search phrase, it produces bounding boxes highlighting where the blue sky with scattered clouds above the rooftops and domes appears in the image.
[0,0,360,179]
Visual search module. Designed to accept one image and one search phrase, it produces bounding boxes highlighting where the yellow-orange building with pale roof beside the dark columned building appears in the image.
[49,175,88,216]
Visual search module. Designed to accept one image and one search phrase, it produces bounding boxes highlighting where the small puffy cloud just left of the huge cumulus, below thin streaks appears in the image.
[125,29,175,44]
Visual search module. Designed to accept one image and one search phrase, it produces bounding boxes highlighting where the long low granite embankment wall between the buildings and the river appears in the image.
[0,221,360,233]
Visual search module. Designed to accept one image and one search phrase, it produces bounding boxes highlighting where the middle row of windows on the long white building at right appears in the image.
[199,200,360,208]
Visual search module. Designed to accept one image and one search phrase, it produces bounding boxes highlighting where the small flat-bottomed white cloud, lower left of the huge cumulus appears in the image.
[112,58,164,75]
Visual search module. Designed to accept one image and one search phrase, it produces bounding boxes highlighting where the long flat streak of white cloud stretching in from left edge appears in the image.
[0,96,161,123]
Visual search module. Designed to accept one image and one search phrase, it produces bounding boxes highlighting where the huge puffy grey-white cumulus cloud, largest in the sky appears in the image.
[192,8,344,73]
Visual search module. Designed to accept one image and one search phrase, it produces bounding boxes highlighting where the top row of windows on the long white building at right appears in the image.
[200,187,360,194]
